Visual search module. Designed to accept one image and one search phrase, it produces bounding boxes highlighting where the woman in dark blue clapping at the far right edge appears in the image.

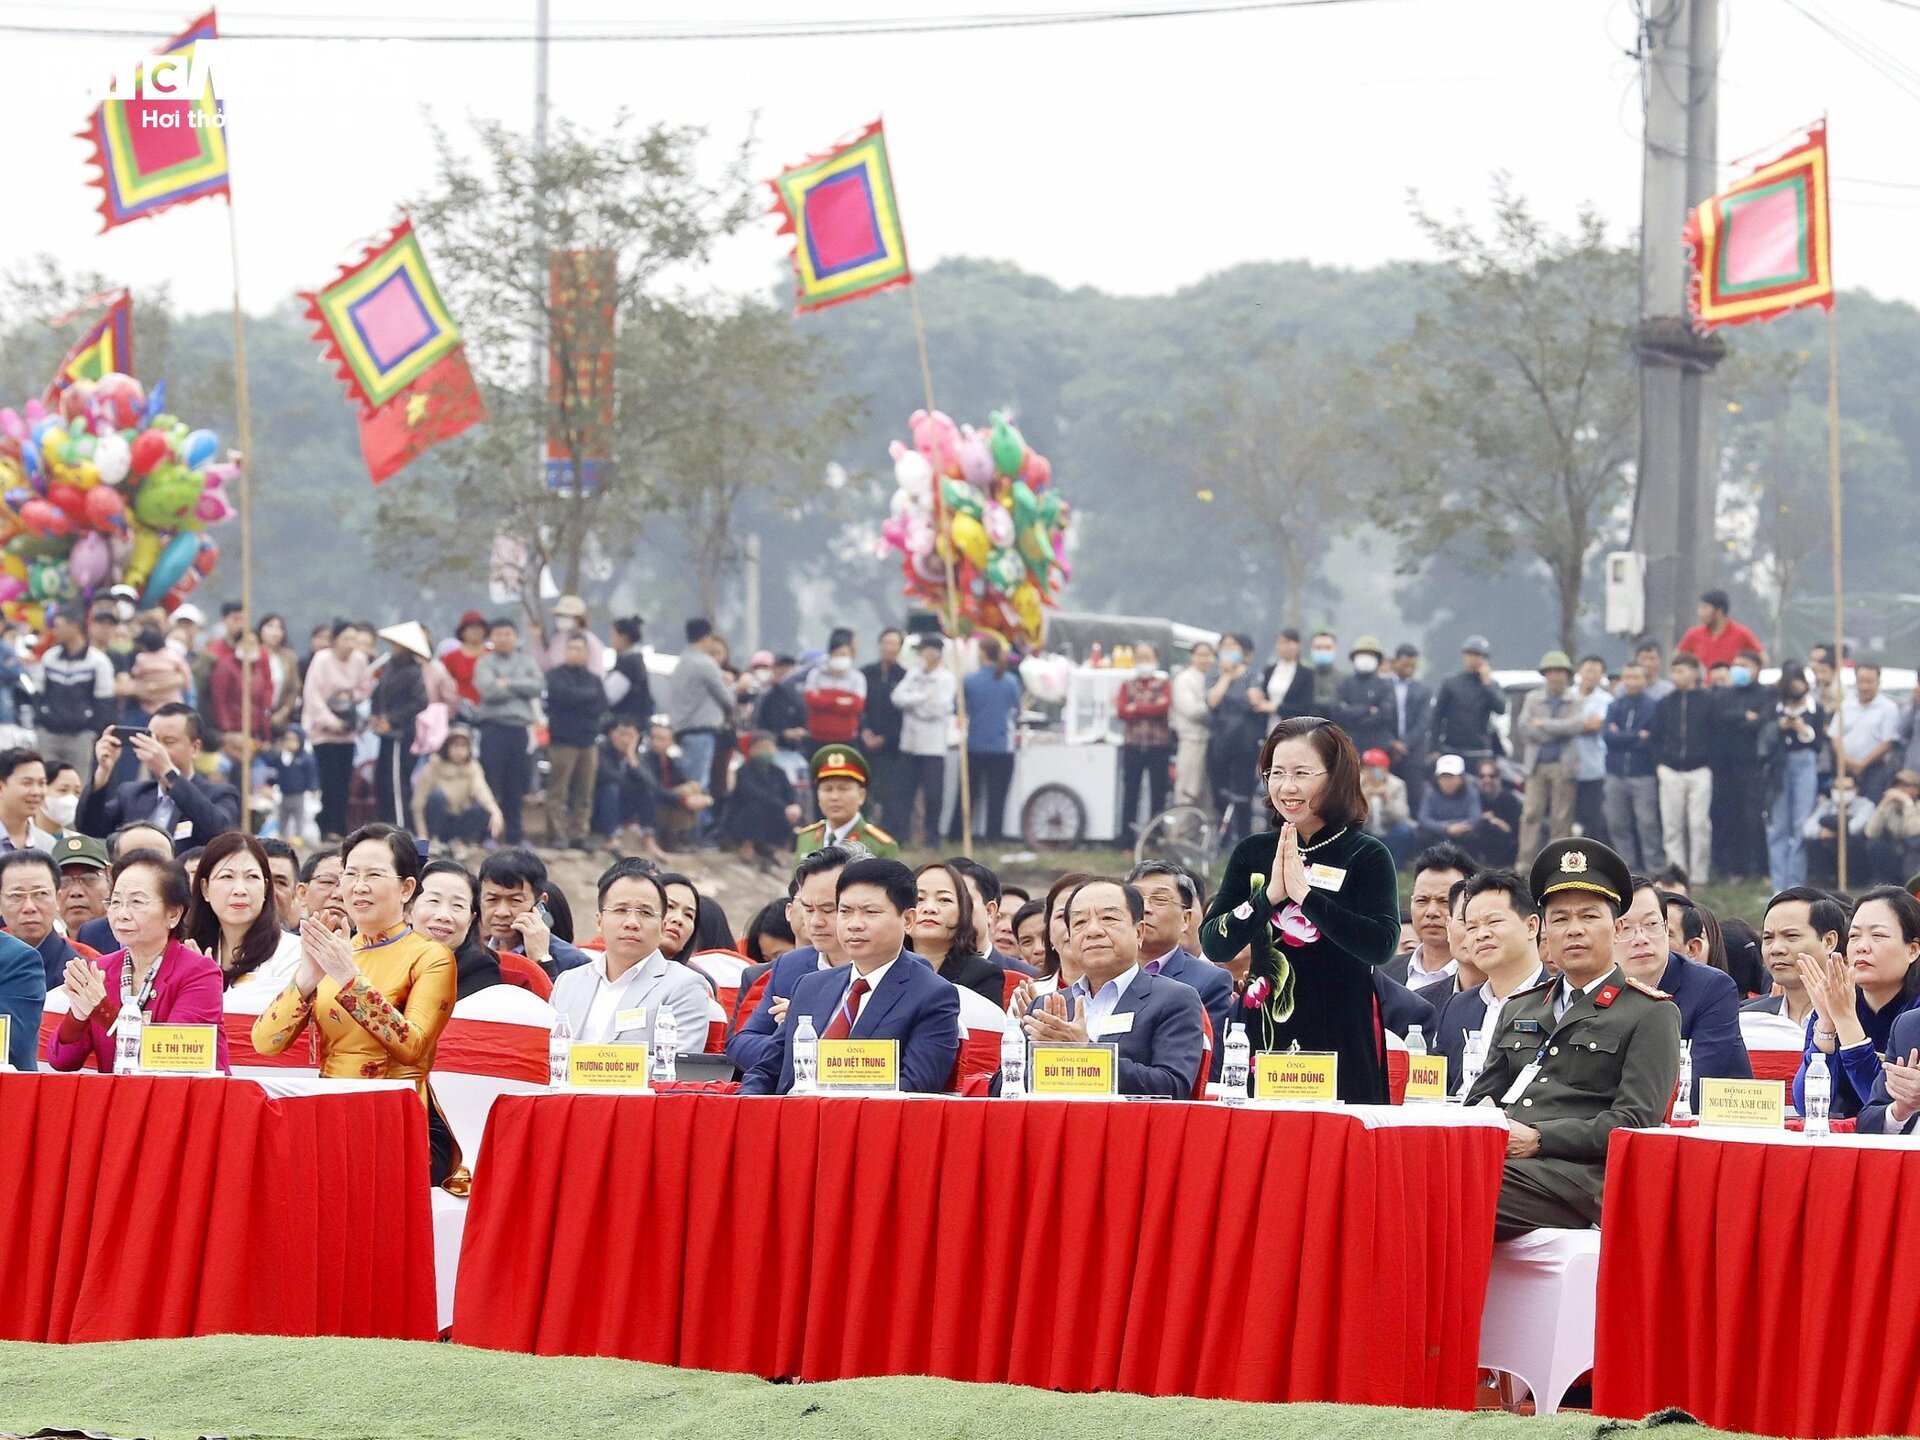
[1793,885,1920,1119]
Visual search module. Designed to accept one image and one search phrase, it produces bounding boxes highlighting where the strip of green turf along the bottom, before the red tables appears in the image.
[0,1336,1758,1440]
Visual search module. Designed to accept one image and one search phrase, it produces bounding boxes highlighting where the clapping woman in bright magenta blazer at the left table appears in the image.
[46,851,230,1075]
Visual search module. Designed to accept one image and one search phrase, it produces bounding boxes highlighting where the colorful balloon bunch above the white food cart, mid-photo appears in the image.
[879,411,1071,649]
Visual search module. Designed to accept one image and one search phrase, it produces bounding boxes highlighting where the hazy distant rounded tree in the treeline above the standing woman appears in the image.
[1185,340,1367,628]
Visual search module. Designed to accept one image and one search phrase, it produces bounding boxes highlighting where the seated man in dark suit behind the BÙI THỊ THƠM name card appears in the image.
[1023,879,1206,1100]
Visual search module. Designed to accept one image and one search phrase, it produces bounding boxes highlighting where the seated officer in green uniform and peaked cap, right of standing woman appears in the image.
[1467,839,1680,1240]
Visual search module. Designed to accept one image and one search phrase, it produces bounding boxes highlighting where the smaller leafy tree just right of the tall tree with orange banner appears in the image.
[637,300,862,616]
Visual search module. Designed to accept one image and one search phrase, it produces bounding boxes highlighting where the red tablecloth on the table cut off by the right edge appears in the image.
[1594,1131,1920,1438]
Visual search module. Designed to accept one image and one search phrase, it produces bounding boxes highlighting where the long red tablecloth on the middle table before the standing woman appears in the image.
[453,1094,1505,1409]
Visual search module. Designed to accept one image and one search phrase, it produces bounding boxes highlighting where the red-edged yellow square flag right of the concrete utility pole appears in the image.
[1684,121,1834,330]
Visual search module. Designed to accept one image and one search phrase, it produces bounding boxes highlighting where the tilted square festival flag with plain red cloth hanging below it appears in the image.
[300,221,486,484]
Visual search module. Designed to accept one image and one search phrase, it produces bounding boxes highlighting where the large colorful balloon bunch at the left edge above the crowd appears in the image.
[0,374,240,626]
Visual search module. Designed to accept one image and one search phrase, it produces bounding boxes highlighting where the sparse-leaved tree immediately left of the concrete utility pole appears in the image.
[1373,179,1638,649]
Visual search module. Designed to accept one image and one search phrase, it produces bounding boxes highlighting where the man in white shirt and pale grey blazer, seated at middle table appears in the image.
[553,856,707,1054]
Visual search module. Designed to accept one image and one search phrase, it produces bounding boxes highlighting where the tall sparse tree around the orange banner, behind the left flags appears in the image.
[382,115,753,614]
